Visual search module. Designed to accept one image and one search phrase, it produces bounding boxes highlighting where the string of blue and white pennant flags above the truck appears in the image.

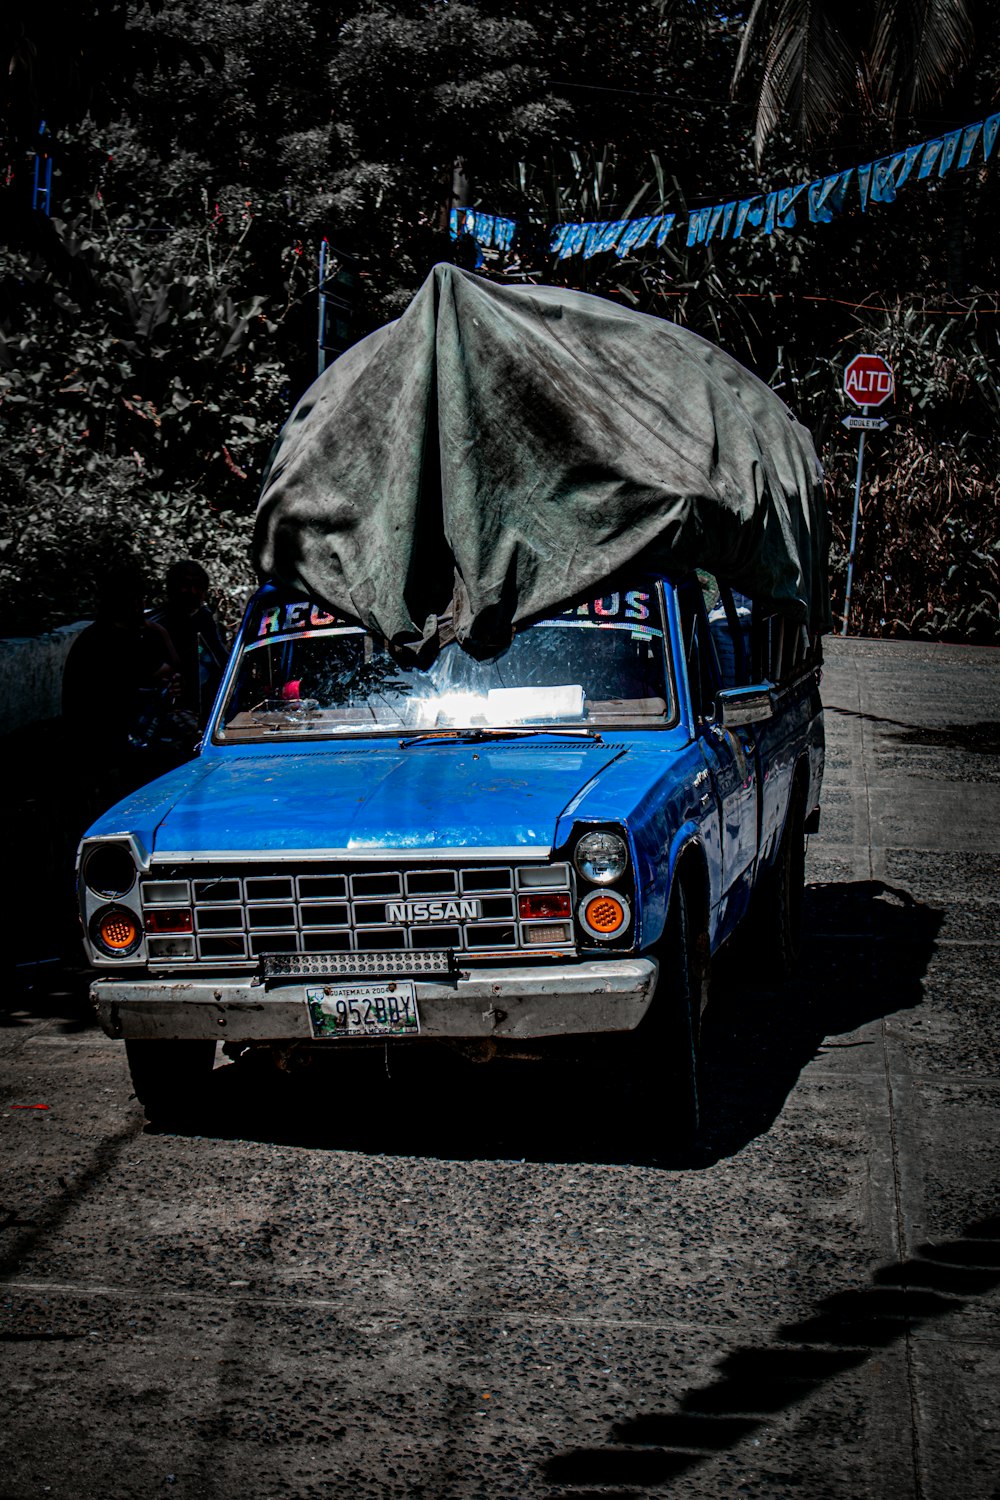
[451,114,1000,261]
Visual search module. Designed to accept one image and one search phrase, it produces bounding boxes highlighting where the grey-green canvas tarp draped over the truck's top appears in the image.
[255,266,829,650]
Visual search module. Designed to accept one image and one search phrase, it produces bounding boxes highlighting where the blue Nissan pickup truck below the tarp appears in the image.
[79,573,823,1122]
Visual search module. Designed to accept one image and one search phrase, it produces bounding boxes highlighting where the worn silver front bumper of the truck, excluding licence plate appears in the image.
[90,959,660,1047]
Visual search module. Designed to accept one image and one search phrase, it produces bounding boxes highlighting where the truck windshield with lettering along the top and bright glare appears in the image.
[216,584,673,741]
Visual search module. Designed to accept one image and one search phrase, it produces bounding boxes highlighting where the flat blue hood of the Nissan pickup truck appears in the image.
[153,740,627,858]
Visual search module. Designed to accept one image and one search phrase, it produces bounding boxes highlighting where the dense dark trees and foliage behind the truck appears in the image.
[0,0,1000,641]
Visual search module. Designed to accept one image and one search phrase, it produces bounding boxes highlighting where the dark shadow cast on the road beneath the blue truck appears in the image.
[199,881,942,1169]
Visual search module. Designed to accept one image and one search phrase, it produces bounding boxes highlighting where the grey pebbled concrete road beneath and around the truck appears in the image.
[0,641,1000,1500]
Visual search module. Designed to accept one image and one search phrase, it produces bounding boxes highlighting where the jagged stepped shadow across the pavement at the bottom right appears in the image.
[543,1215,1000,1500]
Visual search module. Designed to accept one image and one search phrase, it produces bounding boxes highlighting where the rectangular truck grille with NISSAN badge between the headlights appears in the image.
[141,864,574,966]
